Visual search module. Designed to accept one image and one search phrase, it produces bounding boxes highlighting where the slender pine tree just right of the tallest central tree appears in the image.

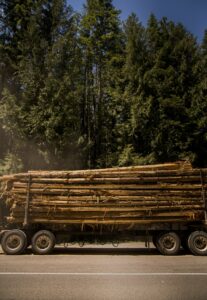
[116,14,148,165]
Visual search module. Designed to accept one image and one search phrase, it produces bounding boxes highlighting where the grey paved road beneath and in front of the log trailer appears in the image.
[0,243,207,300]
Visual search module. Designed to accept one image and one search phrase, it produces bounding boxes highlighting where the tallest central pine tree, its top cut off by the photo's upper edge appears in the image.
[81,0,122,167]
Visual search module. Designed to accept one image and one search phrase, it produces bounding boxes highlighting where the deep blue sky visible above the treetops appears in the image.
[68,0,207,41]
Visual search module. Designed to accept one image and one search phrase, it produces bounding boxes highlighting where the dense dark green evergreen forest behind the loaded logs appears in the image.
[0,0,207,174]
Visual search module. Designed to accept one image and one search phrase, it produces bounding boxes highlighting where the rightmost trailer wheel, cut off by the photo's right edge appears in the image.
[188,231,207,256]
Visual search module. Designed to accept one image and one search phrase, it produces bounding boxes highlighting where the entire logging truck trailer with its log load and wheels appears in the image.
[0,162,207,256]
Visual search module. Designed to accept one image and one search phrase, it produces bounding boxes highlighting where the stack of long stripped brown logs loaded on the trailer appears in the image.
[0,162,207,224]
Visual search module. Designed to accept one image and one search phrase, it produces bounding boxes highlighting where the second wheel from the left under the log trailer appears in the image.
[32,230,55,255]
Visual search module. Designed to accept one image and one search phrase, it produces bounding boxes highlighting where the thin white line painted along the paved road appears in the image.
[0,272,207,276]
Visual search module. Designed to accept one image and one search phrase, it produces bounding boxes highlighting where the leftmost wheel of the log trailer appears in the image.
[1,229,27,255]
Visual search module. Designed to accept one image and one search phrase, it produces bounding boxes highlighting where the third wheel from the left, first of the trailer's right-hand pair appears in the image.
[155,232,181,255]
